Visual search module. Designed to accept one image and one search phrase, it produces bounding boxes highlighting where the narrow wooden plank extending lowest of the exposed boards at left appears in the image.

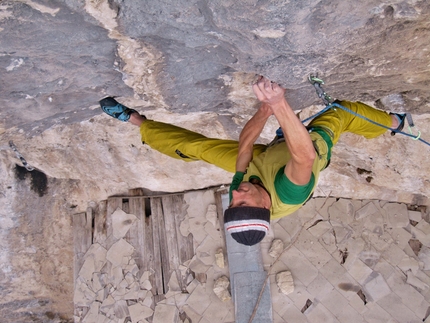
[151,198,164,295]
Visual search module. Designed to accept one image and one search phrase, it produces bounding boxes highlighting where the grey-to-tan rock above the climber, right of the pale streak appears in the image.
[119,0,429,111]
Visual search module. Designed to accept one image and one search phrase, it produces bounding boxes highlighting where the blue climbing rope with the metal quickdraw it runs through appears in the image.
[302,74,430,146]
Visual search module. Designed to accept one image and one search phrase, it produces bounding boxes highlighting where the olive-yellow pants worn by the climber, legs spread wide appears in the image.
[140,101,391,173]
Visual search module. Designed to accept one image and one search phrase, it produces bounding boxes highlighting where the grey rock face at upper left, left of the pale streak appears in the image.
[0,1,132,134]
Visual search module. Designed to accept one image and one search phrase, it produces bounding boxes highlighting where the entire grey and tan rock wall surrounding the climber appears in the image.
[0,0,430,322]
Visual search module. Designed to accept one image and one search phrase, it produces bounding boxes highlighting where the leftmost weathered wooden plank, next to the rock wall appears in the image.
[72,209,93,282]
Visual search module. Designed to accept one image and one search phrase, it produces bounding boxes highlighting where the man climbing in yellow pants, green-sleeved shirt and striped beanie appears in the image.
[100,77,405,245]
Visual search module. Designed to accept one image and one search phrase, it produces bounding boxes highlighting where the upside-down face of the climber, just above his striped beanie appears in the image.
[230,182,267,208]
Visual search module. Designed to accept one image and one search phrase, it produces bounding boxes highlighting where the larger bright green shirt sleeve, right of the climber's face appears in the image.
[275,166,315,205]
